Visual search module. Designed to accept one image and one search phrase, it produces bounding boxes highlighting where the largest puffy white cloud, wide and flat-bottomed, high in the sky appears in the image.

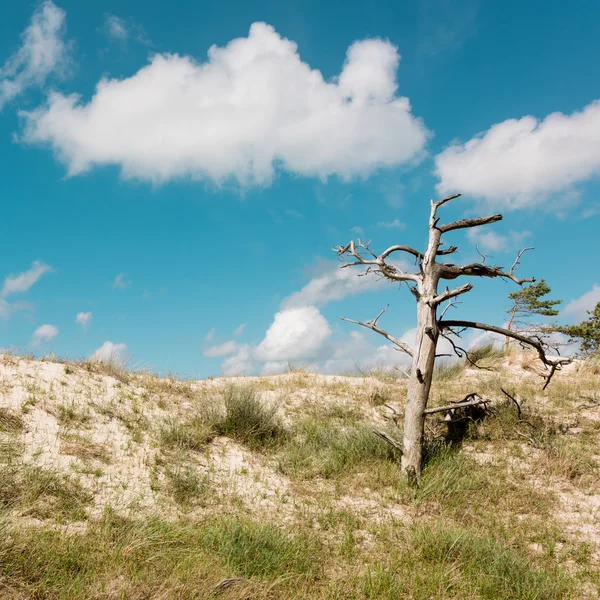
[21,23,429,185]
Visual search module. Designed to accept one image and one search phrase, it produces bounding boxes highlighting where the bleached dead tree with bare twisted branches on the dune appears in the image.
[335,194,570,479]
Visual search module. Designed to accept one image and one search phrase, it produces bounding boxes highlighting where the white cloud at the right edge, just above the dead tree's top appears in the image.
[435,100,600,209]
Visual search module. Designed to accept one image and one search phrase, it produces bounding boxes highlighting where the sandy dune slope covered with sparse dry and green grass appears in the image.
[0,348,600,600]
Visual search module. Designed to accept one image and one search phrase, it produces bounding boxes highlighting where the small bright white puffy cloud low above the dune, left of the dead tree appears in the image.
[255,306,331,361]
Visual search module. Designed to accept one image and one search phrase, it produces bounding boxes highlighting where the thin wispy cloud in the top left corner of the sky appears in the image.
[0,0,69,110]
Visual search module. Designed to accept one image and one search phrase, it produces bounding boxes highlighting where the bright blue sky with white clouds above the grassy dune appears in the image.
[0,0,600,377]
